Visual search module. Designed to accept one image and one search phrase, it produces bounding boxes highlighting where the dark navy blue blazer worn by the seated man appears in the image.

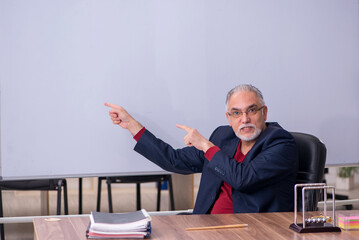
[135,123,298,214]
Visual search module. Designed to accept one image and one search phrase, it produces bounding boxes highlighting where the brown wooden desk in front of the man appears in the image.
[34,211,359,240]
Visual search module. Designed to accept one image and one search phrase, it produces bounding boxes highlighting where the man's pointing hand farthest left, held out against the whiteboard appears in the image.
[105,103,143,136]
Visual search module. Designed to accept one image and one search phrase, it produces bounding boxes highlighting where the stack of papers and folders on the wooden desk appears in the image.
[86,209,151,239]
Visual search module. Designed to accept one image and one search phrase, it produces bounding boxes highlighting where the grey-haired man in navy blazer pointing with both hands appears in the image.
[105,85,298,214]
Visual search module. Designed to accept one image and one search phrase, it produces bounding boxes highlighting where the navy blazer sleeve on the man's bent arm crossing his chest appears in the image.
[207,128,298,192]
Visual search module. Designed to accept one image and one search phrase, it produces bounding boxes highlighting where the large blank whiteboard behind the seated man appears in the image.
[0,0,359,179]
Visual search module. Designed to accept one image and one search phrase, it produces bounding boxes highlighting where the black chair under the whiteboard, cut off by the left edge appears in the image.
[0,179,69,240]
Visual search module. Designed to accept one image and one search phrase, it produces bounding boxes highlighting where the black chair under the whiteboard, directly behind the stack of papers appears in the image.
[96,174,175,213]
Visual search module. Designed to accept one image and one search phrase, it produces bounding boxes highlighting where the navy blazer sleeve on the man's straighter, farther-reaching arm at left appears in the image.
[134,130,205,174]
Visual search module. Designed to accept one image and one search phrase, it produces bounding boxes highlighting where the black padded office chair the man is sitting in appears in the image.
[291,132,327,211]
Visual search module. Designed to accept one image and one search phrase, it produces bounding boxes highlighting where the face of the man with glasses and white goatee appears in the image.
[226,91,267,142]
